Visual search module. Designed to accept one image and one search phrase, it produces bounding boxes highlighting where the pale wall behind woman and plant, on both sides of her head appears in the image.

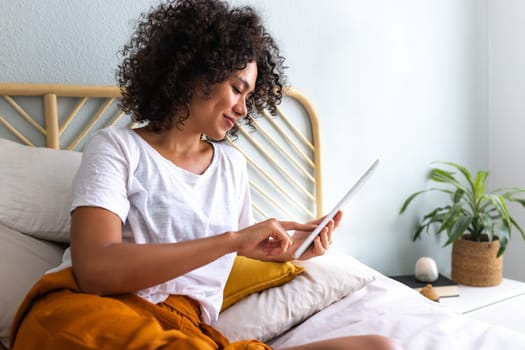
[0,0,489,274]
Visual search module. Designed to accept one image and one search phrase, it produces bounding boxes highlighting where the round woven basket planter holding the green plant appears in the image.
[451,239,503,287]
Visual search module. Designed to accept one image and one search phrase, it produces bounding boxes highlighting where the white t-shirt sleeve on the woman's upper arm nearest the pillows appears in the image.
[71,128,131,223]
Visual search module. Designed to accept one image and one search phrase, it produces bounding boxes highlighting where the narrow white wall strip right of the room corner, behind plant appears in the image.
[488,0,525,281]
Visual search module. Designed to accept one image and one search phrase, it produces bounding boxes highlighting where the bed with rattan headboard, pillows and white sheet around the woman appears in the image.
[0,83,525,350]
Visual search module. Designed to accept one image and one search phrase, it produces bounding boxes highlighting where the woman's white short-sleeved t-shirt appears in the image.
[52,127,252,323]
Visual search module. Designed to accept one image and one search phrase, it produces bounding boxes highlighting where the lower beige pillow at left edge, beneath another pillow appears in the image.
[0,225,63,337]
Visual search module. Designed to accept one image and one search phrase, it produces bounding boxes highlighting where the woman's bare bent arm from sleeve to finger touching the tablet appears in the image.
[71,207,300,294]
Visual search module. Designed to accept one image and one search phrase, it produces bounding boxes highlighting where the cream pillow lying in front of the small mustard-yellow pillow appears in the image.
[213,252,374,342]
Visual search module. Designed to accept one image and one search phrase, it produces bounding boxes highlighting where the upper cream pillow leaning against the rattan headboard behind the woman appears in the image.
[0,139,81,242]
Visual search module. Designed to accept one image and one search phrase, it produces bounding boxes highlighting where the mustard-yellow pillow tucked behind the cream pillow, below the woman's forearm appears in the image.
[221,256,304,311]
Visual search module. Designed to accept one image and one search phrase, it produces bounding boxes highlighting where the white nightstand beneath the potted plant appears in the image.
[439,278,525,333]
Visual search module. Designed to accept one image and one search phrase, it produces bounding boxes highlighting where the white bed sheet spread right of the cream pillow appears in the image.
[270,256,525,350]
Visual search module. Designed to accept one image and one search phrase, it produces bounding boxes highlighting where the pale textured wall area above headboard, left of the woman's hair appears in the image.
[0,0,156,84]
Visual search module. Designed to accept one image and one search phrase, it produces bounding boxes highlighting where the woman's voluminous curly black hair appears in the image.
[116,0,285,134]
